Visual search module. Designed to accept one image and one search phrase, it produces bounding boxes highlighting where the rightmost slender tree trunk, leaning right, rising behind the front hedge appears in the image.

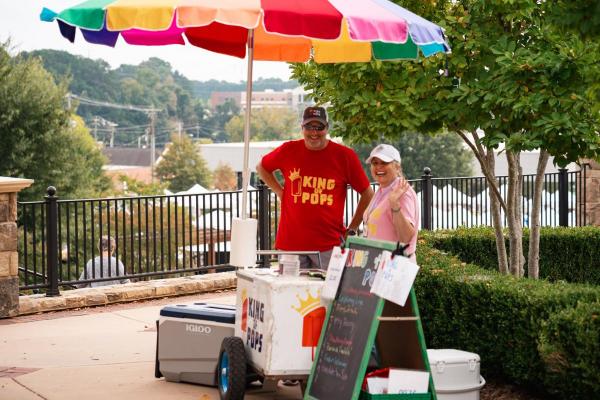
[527,150,549,279]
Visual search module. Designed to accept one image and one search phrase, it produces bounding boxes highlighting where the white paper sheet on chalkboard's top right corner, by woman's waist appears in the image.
[371,255,419,307]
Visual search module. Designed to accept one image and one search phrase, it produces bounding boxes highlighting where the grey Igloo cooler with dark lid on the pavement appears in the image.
[155,303,235,386]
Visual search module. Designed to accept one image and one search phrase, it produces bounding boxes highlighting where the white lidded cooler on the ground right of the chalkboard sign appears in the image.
[427,349,485,400]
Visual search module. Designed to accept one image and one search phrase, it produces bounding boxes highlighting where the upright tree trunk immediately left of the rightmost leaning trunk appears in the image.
[506,151,524,277]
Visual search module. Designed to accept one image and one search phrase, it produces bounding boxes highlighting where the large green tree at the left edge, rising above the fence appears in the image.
[0,43,109,200]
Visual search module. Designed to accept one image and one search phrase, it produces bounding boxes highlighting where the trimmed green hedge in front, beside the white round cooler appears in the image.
[415,240,600,399]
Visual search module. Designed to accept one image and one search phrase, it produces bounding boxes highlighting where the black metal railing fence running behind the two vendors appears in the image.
[18,168,586,295]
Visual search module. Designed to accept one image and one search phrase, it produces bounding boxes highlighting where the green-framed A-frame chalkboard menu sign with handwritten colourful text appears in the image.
[304,237,437,400]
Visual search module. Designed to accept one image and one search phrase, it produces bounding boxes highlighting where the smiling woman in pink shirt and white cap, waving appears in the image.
[363,144,419,262]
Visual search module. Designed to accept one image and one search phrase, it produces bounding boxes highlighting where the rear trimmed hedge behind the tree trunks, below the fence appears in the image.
[422,227,600,285]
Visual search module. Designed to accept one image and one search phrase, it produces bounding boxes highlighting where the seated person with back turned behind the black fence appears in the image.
[77,236,130,288]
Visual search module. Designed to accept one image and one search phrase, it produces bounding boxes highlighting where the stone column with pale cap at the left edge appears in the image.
[0,177,33,318]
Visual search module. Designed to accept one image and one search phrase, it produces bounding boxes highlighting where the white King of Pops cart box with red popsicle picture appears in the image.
[235,268,327,379]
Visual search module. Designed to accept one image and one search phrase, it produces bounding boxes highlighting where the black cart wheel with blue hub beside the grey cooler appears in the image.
[217,336,246,400]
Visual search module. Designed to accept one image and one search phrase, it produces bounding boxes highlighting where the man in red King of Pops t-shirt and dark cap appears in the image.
[256,107,373,269]
